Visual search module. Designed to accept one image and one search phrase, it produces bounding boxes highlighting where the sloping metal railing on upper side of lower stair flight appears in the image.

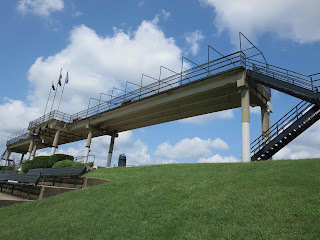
[251,101,313,155]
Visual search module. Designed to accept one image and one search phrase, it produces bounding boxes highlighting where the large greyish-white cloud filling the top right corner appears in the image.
[200,0,320,43]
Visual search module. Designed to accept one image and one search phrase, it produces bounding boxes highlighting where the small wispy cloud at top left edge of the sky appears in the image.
[17,0,64,17]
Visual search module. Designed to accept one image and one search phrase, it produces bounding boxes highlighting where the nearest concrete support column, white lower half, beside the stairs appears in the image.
[241,88,251,162]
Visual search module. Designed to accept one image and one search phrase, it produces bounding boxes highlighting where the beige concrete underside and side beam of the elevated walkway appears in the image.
[8,67,270,154]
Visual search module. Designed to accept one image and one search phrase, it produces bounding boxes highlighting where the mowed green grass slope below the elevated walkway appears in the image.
[0,159,320,240]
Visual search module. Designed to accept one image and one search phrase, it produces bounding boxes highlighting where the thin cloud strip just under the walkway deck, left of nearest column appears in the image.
[180,109,234,125]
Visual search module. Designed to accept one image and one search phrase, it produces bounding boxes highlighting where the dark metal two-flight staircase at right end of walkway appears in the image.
[247,60,320,161]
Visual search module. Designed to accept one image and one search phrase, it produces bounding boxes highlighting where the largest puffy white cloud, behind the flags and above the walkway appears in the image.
[28,21,181,113]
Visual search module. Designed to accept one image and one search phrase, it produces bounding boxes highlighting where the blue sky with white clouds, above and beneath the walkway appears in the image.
[0,0,320,166]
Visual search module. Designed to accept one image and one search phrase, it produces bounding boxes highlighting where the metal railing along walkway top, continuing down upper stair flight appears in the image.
[7,49,318,145]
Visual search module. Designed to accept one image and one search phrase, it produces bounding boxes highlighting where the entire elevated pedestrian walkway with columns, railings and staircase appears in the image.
[3,47,320,165]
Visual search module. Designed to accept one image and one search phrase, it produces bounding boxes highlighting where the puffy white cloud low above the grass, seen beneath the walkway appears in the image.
[154,137,229,161]
